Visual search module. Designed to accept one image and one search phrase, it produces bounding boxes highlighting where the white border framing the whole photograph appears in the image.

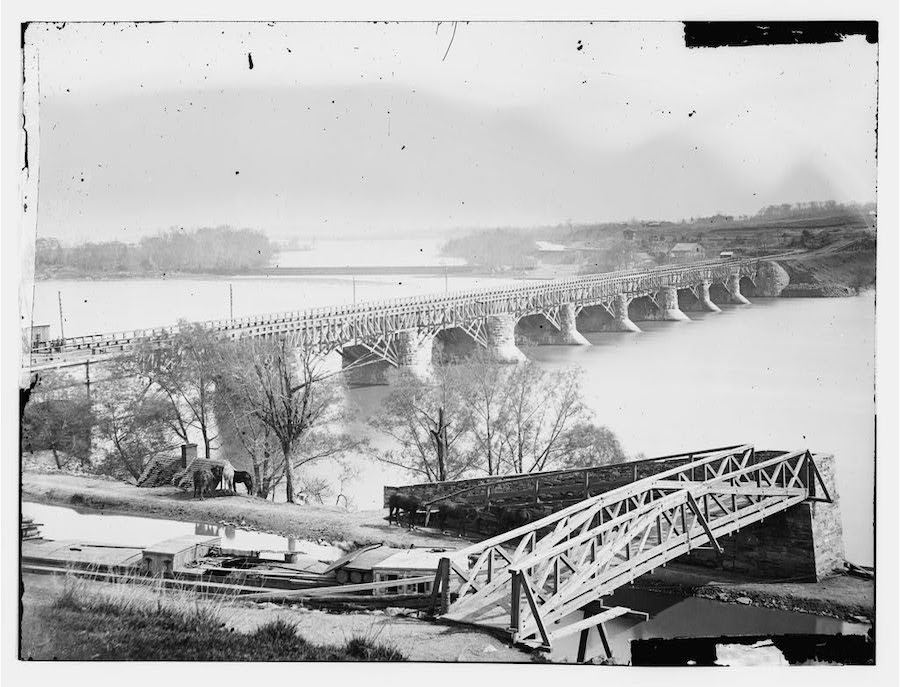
[0,0,900,686]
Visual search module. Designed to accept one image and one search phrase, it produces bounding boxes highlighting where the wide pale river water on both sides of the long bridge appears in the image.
[28,243,875,564]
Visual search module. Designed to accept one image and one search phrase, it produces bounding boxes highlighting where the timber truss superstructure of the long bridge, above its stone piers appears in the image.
[23,256,777,371]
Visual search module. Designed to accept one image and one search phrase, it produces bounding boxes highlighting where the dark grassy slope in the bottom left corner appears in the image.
[22,578,405,661]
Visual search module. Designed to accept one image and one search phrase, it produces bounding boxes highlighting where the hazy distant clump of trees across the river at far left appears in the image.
[35,225,276,275]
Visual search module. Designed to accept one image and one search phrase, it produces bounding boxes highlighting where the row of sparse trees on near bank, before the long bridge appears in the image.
[23,323,626,503]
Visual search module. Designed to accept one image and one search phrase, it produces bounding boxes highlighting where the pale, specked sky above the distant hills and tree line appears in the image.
[26,22,877,241]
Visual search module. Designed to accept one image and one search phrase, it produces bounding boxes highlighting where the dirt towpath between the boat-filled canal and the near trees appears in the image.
[22,472,472,547]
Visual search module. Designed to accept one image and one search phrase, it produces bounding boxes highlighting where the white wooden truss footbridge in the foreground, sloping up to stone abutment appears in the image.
[434,445,831,653]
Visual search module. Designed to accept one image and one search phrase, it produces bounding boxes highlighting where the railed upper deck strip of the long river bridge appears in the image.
[31,258,759,356]
